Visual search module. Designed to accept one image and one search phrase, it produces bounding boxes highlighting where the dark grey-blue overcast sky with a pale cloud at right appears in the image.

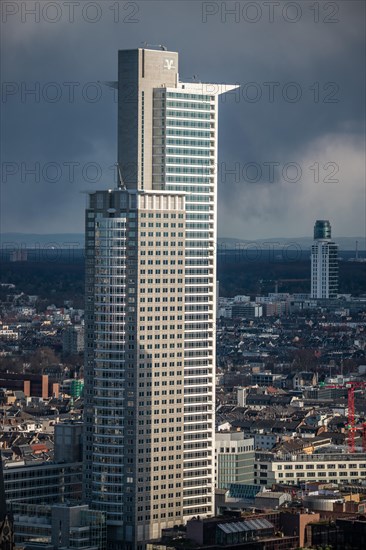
[1,0,366,239]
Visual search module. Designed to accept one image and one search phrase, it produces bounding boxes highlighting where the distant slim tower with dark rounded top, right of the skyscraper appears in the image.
[311,220,338,298]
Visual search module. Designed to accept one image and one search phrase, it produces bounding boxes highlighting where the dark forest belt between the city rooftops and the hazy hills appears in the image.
[0,250,366,302]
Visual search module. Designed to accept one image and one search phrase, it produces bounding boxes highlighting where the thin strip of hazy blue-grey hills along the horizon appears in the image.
[0,233,366,252]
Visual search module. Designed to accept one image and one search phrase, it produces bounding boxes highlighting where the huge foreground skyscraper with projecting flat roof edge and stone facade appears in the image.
[84,49,236,549]
